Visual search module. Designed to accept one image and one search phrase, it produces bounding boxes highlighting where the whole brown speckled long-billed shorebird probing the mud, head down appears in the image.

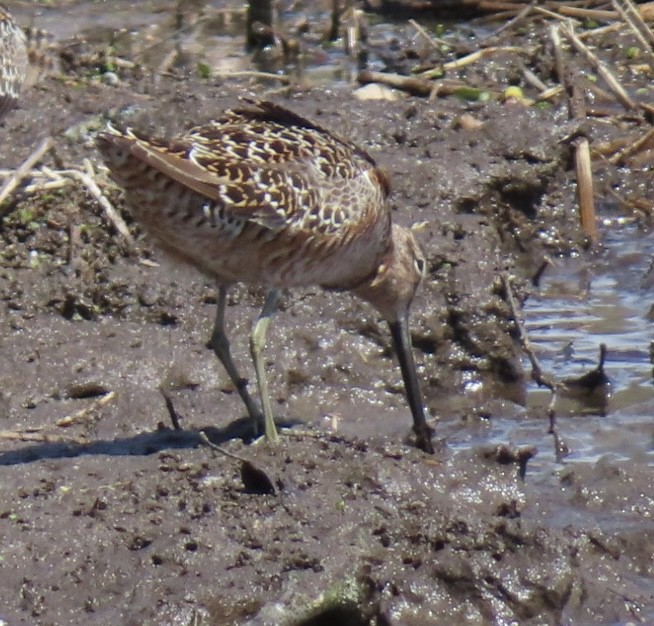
[97,102,433,452]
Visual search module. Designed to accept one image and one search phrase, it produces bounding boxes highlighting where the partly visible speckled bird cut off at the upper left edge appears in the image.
[0,5,28,117]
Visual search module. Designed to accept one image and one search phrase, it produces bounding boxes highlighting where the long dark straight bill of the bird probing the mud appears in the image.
[388,315,434,454]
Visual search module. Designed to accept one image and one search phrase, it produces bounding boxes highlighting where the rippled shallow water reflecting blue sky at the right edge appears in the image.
[524,221,654,463]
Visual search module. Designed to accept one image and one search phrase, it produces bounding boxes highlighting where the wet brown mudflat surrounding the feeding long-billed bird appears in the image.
[0,3,654,626]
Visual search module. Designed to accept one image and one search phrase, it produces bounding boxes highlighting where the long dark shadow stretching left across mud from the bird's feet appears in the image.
[0,418,297,466]
